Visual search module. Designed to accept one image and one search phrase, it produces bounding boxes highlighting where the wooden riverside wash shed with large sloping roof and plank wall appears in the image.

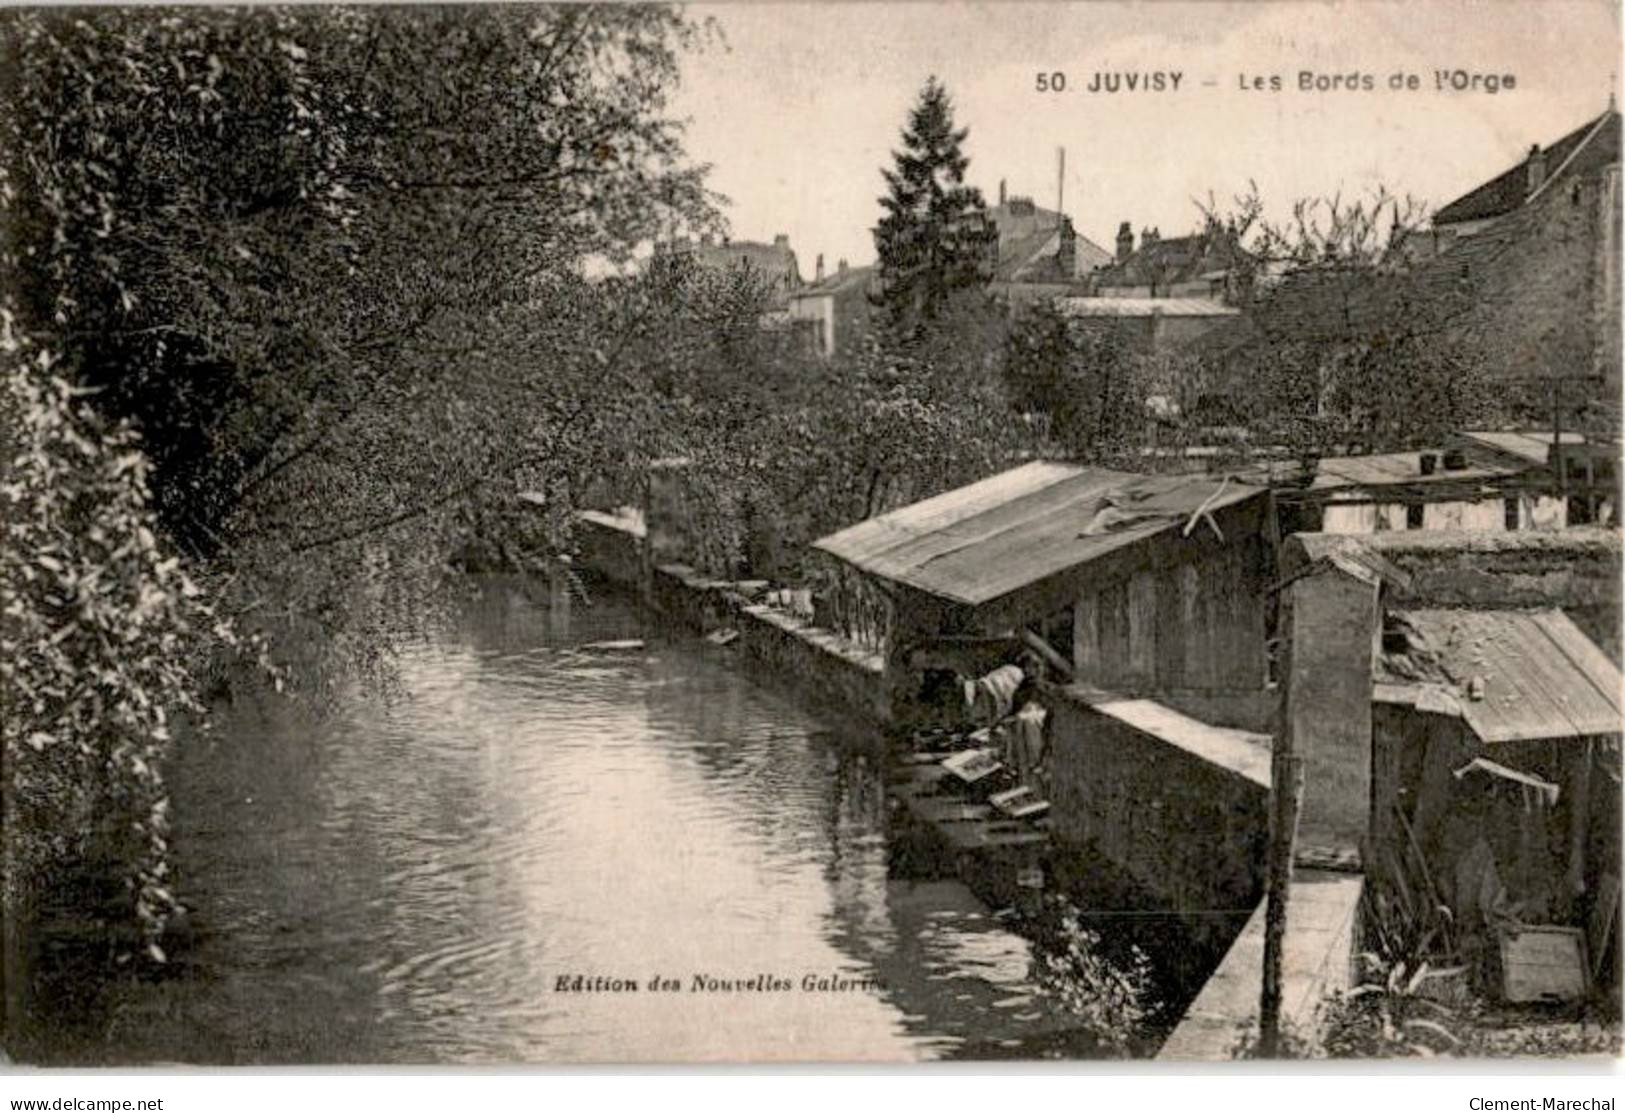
[814,461,1274,692]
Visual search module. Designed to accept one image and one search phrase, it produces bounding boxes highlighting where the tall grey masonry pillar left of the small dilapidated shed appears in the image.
[1282,559,1380,856]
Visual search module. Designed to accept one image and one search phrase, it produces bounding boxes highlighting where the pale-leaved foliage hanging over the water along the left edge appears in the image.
[0,314,257,960]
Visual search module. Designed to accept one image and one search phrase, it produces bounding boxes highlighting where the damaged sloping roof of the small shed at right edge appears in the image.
[1376,609,1620,743]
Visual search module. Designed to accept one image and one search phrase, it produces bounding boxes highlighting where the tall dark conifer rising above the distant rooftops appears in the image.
[874,76,996,330]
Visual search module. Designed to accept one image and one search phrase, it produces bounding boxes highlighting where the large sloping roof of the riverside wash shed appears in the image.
[814,461,1263,606]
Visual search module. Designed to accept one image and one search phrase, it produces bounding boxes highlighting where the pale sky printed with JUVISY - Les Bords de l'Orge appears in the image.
[674,0,1620,278]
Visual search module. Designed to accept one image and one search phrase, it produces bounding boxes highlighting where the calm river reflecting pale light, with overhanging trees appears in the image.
[76,580,1092,1063]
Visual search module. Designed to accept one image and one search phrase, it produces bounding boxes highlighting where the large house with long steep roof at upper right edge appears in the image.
[1199,107,1622,434]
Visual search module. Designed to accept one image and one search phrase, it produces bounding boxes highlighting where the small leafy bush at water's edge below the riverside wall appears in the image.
[1034,899,1155,1058]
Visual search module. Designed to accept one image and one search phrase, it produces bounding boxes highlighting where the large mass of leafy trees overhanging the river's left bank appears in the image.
[0,5,715,1013]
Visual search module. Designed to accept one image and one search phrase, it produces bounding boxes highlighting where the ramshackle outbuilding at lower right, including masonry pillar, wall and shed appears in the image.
[1282,530,1622,996]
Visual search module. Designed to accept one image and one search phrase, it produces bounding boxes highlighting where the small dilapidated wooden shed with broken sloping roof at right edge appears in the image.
[1372,608,1622,954]
